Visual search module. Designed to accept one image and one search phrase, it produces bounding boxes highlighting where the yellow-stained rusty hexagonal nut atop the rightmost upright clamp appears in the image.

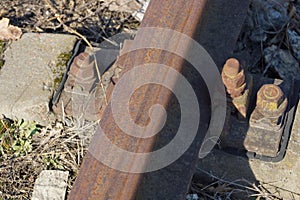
[256,84,287,116]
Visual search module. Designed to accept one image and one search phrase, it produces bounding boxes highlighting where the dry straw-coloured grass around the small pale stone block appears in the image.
[0,119,97,199]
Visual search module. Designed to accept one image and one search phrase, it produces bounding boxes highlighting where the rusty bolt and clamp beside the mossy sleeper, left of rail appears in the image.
[52,52,102,120]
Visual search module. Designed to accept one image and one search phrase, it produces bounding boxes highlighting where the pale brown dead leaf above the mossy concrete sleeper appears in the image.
[0,18,22,41]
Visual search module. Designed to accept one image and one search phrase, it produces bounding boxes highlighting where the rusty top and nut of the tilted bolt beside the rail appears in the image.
[222,58,246,98]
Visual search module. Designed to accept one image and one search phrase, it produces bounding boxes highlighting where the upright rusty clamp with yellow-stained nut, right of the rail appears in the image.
[244,84,288,157]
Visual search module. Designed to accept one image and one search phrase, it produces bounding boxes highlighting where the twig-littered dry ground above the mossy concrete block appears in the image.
[0,0,139,42]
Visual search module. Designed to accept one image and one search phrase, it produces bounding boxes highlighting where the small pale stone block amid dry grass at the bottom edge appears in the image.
[32,170,69,200]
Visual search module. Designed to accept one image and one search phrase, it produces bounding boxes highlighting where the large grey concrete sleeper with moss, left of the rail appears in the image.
[0,33,77,125]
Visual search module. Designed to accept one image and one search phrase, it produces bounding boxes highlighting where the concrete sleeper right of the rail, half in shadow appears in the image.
[196,97,300,200]
